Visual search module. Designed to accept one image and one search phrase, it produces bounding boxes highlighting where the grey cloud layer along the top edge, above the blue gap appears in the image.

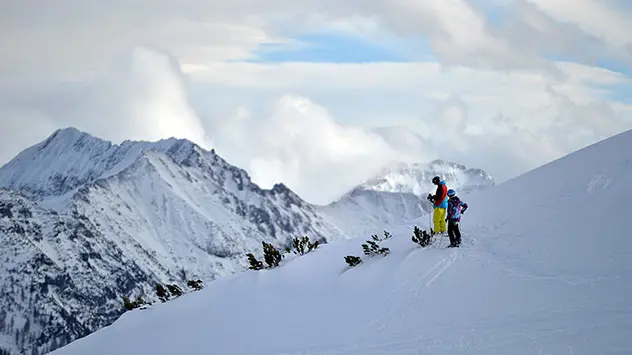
[0,0,632,84]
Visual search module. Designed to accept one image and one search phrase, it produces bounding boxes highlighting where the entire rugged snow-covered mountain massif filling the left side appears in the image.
[0,128,344,353]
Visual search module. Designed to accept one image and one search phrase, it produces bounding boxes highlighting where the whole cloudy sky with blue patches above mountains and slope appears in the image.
[0,0,632,204]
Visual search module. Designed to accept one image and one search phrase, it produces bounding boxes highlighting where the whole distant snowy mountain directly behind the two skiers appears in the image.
[322,159,495,235]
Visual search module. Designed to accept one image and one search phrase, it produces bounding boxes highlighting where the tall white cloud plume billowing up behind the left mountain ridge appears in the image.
[73,48,209,148]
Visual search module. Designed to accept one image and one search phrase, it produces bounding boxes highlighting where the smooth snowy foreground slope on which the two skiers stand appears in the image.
[53,131,632,355]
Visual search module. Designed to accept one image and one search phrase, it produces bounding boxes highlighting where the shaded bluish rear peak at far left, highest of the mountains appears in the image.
[0,128,200,210]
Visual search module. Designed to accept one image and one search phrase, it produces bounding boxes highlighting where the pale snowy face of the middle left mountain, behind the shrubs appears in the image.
[74,149,342,282]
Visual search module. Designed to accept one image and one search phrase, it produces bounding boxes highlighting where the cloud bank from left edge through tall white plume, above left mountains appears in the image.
[0,47,210,158]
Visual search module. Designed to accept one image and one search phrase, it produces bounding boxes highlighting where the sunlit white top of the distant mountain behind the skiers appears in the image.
[359,160,494,196]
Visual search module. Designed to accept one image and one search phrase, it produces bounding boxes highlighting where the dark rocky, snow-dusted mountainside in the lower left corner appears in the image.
[0,189,158,354]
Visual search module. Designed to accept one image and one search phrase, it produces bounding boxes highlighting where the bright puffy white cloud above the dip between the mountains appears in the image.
[207,95,421,204]
